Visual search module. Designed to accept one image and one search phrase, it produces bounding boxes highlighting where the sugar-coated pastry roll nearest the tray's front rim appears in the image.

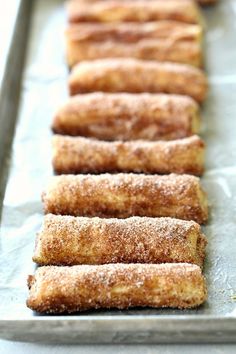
[27,263,207,313]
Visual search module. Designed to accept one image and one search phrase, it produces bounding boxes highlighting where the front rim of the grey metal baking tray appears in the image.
[0,315,236,344]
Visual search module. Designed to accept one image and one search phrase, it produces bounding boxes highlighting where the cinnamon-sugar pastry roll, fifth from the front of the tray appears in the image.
[52,92,200,140]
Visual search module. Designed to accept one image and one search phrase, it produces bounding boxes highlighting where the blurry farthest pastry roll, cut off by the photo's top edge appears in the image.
[67,0,201,23]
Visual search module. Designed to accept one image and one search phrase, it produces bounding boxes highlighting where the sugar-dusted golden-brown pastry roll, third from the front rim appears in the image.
[42,173,208,224]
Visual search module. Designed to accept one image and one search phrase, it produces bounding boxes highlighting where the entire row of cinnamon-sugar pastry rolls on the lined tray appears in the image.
[27,0,214,313]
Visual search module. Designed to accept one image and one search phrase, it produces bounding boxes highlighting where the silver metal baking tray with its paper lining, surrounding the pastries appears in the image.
[0,0,236,344]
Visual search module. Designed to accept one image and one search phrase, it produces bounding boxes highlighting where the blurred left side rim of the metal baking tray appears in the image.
[0,0,34,214]
